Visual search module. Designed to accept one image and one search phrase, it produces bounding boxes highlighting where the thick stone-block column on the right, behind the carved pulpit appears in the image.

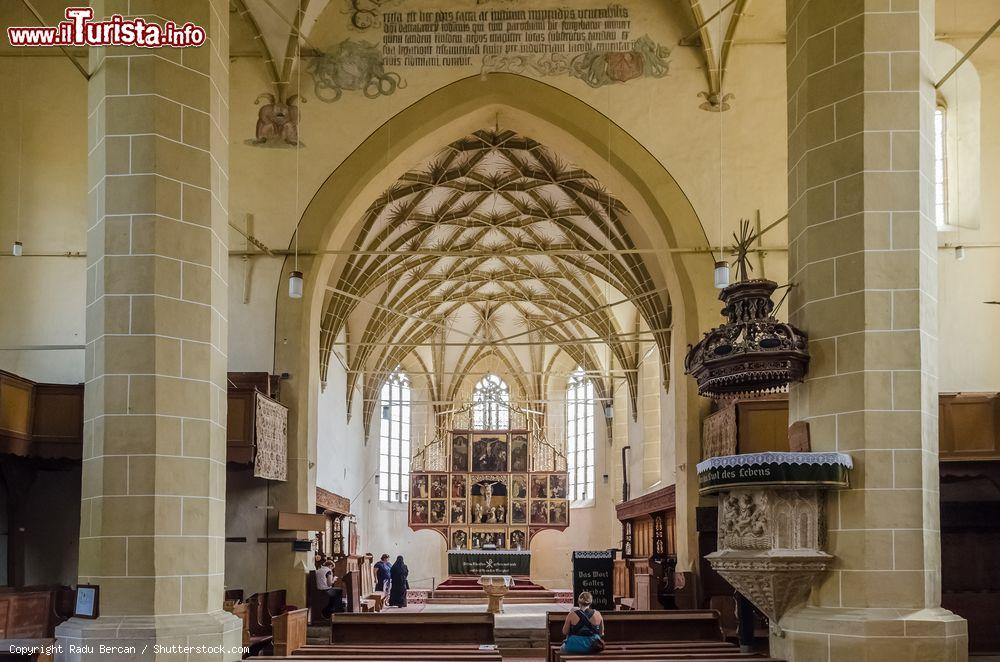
[772,0,968,662]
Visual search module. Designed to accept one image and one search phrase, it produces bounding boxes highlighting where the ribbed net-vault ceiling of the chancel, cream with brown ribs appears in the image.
[321,129,670,436]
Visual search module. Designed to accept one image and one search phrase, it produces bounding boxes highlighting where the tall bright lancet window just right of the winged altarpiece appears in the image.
[566,368,595,501]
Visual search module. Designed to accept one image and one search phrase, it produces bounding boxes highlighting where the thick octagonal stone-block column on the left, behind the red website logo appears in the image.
[56,0,241,660]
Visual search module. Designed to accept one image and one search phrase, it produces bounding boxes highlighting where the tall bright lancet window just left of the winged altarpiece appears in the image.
[378,368,410,502]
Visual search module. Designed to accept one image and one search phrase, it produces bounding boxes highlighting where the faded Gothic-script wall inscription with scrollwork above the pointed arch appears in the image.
[309,0,670,103]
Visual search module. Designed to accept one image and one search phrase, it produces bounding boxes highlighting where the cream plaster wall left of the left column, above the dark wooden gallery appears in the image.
[0,57,87,383]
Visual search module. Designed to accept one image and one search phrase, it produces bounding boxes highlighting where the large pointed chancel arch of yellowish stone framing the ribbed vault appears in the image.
[271,74,714,608]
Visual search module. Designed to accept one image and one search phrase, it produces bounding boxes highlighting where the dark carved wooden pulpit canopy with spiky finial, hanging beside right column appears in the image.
[684,221,809,398]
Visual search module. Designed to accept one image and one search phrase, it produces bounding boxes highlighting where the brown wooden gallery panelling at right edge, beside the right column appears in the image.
[938,393,1000,460]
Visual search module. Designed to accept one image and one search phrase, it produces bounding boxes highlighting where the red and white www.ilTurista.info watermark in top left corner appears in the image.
[7,7,205,48]
